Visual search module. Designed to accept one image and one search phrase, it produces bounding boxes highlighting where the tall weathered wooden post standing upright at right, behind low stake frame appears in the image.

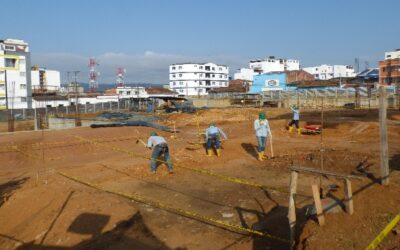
[379,85,389,185]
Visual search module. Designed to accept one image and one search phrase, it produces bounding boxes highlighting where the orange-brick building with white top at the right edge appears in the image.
[379,49,400,85]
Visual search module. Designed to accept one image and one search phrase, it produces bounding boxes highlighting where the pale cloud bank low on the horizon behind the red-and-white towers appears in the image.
[32,51,248,83]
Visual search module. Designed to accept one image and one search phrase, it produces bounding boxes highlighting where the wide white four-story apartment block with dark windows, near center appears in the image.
[169,63,229,96]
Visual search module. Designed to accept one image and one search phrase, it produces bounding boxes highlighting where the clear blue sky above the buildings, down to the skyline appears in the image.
[0,0,400,83]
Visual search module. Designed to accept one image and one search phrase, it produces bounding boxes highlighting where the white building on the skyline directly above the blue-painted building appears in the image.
[250,56,300,74]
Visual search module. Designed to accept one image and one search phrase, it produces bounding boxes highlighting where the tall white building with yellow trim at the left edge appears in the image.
[0,39,32,109]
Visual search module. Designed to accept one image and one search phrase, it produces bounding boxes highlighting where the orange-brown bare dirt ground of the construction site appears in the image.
[0,108,400,249]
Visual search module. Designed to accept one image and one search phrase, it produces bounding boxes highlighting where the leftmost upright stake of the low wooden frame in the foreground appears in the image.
[288,171,298,249]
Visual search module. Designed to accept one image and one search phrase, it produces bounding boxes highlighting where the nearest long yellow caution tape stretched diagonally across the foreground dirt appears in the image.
[58,172,289,243]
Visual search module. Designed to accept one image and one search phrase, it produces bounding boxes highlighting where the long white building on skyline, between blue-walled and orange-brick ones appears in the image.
[303,64,357,80]
